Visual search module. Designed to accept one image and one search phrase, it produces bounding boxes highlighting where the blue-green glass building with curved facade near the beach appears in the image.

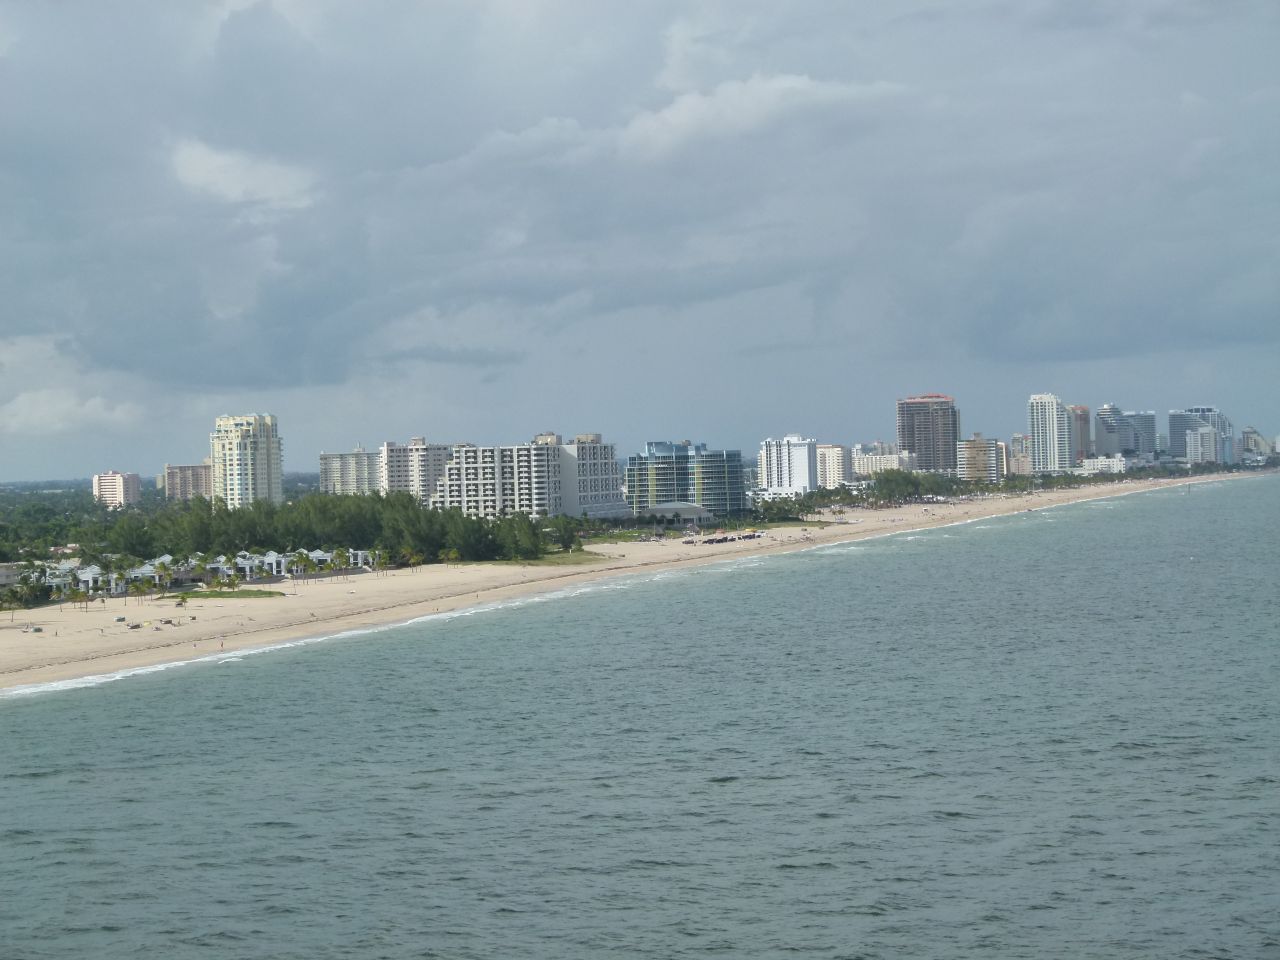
[626,440,746,516]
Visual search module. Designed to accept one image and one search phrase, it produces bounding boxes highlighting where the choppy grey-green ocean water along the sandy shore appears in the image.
[0,476,1280,960]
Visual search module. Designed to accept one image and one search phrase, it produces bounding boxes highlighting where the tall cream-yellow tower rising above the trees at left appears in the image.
[209,413,284,509]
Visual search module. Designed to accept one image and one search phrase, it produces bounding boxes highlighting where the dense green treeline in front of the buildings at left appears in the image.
[0,492,580,566]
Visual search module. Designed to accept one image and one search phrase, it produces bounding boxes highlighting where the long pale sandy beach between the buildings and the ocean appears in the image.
[0,474,1247,690]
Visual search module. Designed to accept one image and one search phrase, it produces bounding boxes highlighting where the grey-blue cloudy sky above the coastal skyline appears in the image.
[0,0,1280,480]
